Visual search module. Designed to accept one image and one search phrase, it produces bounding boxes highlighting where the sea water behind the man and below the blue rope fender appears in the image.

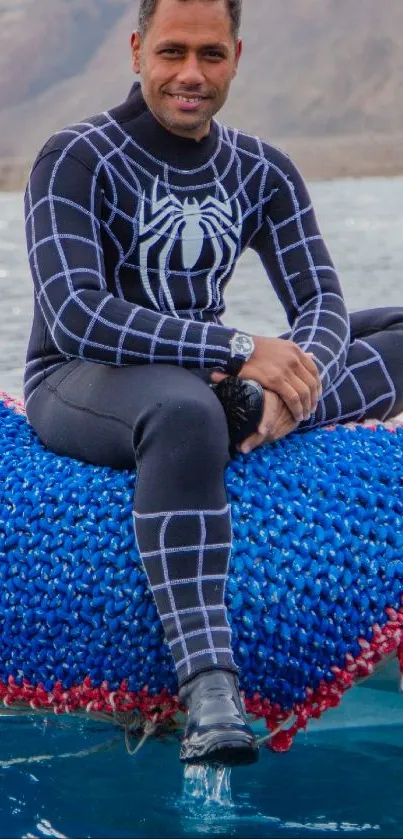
[0,179,403,839]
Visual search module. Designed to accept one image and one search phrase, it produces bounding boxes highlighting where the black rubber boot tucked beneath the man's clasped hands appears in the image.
[211,376,264,446]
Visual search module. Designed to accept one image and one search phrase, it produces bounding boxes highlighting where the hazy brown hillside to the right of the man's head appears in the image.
[221,0,403,137]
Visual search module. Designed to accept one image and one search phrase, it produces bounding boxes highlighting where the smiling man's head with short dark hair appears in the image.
[132,0,241,140]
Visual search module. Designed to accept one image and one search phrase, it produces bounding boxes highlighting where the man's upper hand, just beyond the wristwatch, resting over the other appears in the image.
[211,337,322,423]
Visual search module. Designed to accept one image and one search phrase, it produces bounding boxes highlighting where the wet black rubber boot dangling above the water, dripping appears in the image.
[179,670,259,766]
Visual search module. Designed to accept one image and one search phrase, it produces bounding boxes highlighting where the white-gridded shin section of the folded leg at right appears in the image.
[299,339,396,428]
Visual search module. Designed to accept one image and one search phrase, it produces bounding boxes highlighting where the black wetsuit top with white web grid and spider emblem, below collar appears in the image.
[26,101,354,404]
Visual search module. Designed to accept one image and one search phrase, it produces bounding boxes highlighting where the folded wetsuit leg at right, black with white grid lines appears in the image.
[282,307,403,431]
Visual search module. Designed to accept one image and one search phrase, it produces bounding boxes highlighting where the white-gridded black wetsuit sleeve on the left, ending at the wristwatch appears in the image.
[25,151,234,368]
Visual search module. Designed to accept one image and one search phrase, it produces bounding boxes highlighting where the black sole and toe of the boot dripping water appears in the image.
[180,731,259,766]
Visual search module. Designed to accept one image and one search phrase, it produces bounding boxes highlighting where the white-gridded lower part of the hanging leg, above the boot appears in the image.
[134,506,232,681]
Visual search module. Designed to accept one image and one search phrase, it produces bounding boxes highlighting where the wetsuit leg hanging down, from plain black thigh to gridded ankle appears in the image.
[27,360,237,685]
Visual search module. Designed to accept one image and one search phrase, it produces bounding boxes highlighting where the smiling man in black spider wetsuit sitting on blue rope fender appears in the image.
[25,0,403,764]
